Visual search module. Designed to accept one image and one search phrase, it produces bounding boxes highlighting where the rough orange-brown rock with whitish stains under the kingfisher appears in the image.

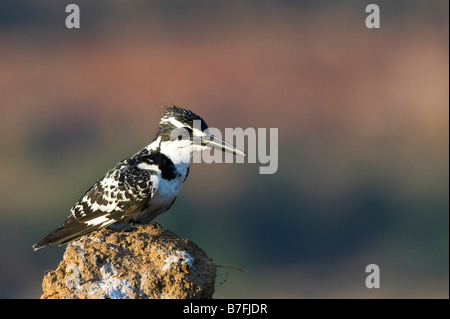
[41,224,216,299]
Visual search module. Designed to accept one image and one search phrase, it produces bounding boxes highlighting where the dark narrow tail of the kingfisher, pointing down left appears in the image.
[33,216,99,251]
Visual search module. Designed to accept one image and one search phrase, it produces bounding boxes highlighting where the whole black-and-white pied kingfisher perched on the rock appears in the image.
[33,106,246,250]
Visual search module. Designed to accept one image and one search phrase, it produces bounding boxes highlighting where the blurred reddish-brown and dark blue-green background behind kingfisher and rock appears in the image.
[0,0,449,298]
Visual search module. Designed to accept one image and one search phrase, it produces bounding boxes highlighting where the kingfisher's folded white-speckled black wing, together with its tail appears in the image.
[33,162,156,250]
